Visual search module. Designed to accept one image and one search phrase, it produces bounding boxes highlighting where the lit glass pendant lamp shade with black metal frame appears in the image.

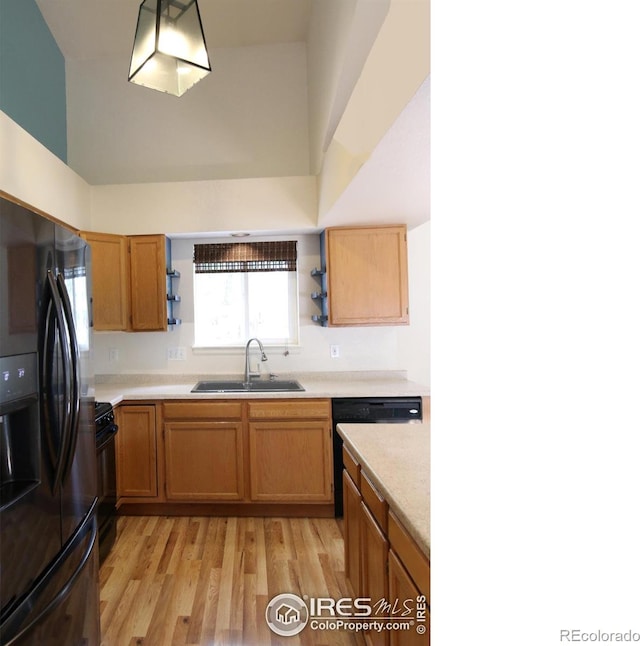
[129,0,211,96]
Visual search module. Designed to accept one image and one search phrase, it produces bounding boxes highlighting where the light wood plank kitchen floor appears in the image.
[100,516,362,646]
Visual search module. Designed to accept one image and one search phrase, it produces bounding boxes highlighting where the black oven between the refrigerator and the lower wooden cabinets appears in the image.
[96,402,118,564]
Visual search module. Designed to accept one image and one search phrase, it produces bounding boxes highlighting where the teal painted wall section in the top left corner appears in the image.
[0,0,67,163]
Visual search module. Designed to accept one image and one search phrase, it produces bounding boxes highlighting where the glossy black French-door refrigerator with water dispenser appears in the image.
[0,197,100,646]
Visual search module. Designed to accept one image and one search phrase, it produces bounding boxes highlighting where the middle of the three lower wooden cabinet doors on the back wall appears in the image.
[164,422,244,502]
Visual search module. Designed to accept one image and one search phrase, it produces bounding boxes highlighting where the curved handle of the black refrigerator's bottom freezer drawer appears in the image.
[0,503,98,646]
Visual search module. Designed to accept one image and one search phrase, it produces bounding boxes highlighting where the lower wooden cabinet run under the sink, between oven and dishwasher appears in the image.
[116,399,333,516]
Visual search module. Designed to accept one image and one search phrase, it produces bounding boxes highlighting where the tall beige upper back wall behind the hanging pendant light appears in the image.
[67,43,309,184]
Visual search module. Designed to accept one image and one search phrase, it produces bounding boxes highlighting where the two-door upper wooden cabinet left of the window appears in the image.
[82,232,168,332]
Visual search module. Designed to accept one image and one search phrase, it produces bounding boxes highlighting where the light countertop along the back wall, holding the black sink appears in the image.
[95,372,429,406]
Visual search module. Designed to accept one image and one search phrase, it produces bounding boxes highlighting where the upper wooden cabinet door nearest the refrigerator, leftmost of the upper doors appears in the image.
[82,231,129,330]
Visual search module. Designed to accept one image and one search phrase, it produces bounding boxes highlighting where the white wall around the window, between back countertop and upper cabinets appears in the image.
[94,234,424,383]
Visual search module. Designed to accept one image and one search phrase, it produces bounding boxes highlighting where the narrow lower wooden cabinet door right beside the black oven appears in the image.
[116,405,158,498]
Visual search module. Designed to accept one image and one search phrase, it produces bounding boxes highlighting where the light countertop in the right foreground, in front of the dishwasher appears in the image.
[338,422,431,558]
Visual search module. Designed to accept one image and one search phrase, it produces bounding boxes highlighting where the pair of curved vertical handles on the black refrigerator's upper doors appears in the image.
[42,271,71,493]
